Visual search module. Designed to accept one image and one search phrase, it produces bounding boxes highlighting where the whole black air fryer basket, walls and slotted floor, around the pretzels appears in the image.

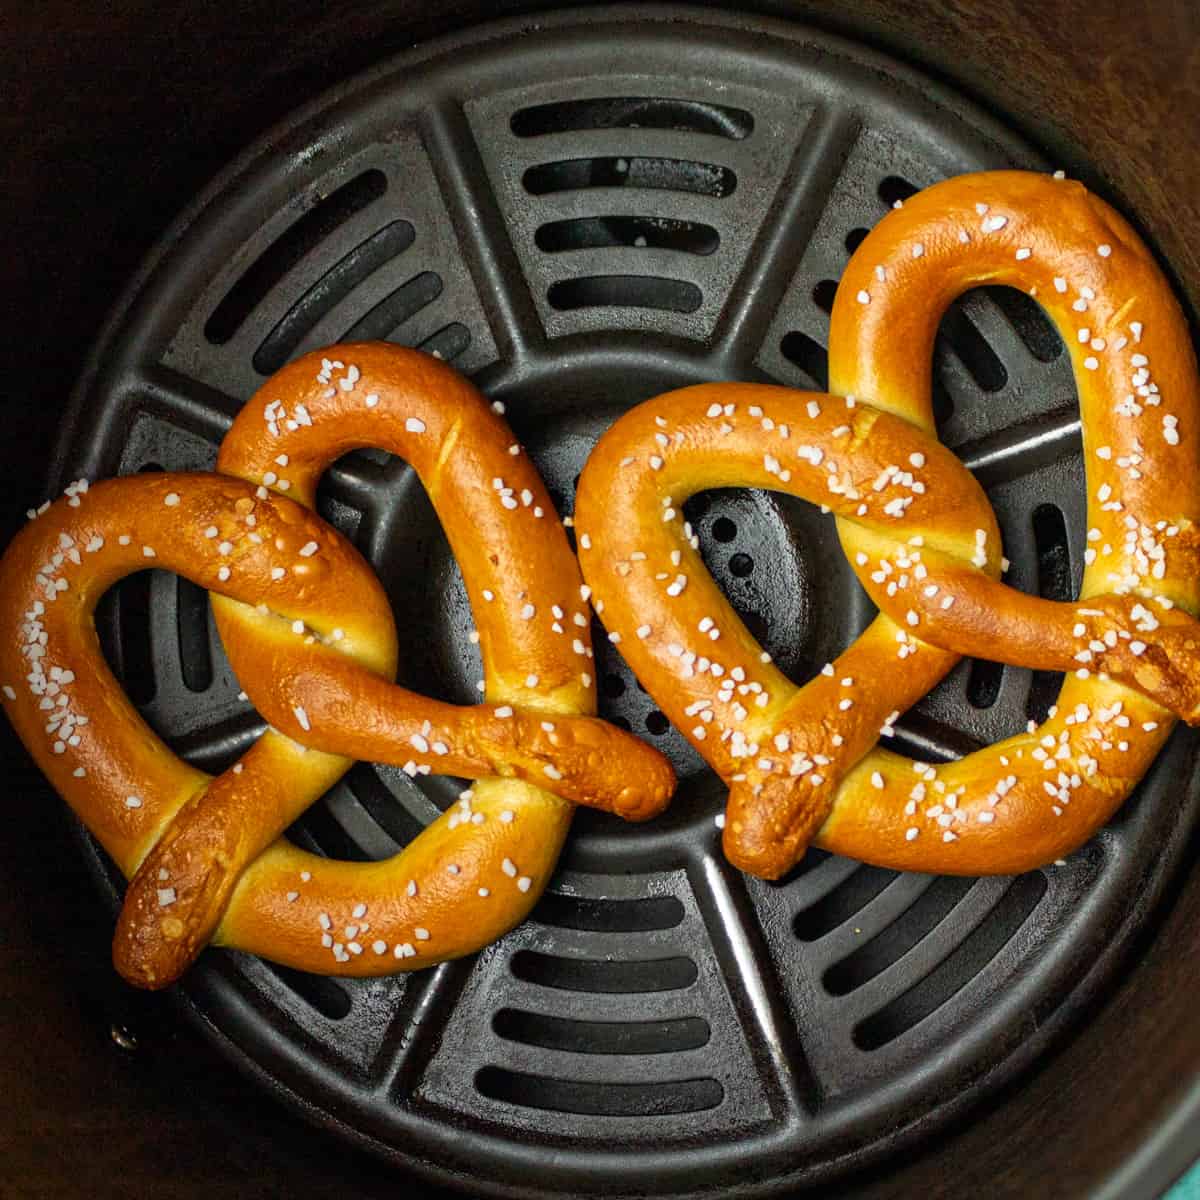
[0,2,1200,1200]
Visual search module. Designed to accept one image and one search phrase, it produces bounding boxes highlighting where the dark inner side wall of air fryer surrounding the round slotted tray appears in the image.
[0,6,1196,1195]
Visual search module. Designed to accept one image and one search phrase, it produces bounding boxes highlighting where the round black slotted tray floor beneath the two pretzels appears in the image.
[59,8,1198,1198]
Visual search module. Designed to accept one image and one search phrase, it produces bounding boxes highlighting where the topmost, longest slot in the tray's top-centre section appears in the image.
[509,96,754,142]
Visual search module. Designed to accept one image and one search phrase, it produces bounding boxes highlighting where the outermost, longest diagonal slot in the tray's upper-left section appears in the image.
[204,170,388,346]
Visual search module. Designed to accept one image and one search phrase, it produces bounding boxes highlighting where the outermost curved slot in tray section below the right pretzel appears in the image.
[853,871,1046,1050]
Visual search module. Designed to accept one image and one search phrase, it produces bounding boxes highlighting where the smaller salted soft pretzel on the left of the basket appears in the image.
[0,343,674,986]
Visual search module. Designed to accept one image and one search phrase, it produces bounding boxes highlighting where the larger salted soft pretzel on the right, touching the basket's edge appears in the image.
[576,172,1200,878]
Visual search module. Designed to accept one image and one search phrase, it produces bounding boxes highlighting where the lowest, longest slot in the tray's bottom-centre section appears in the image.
[475,1067,725,1117]
